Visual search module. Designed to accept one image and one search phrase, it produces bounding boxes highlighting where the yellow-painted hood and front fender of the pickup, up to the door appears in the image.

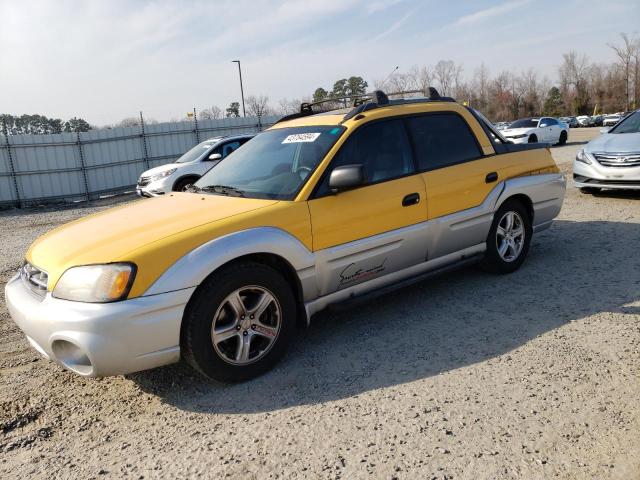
[27,193,312,297]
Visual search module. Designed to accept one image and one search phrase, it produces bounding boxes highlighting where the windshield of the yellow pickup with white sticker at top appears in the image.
[194,126,345,200]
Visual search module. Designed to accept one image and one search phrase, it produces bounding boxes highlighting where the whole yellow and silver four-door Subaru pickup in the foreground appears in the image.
[5,89,565,381]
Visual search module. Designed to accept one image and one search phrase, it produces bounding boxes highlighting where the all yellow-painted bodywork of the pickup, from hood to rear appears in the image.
[27,102,558,298]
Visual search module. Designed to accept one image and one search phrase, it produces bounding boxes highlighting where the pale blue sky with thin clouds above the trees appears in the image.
[0,0,640,125]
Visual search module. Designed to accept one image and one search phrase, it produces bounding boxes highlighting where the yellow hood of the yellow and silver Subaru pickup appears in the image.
[27,192,278,289]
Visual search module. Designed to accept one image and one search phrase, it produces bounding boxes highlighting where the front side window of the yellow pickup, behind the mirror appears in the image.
[318,120,415,195]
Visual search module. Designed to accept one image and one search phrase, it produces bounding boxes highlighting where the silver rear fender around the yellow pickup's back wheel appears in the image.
[494,173,566,232]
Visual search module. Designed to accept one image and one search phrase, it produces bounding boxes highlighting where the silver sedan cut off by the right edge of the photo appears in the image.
[573,110,640,193]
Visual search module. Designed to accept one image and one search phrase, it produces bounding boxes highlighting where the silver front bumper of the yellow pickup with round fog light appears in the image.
[5,275,194,377]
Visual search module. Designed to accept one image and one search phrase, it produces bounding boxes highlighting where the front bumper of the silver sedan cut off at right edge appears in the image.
[573,160,640,190]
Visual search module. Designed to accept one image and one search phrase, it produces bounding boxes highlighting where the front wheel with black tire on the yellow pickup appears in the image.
[180,262,297,382]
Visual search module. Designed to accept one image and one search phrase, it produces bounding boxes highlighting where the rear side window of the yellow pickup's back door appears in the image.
[407,113,482,171]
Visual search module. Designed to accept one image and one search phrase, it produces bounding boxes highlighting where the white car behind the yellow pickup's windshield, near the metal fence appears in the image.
[136,135,253,197]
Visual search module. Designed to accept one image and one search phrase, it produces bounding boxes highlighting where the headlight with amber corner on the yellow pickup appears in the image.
[52,263,136,303]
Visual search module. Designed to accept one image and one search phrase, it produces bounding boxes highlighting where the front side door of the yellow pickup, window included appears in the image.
[308,120,427,295]
